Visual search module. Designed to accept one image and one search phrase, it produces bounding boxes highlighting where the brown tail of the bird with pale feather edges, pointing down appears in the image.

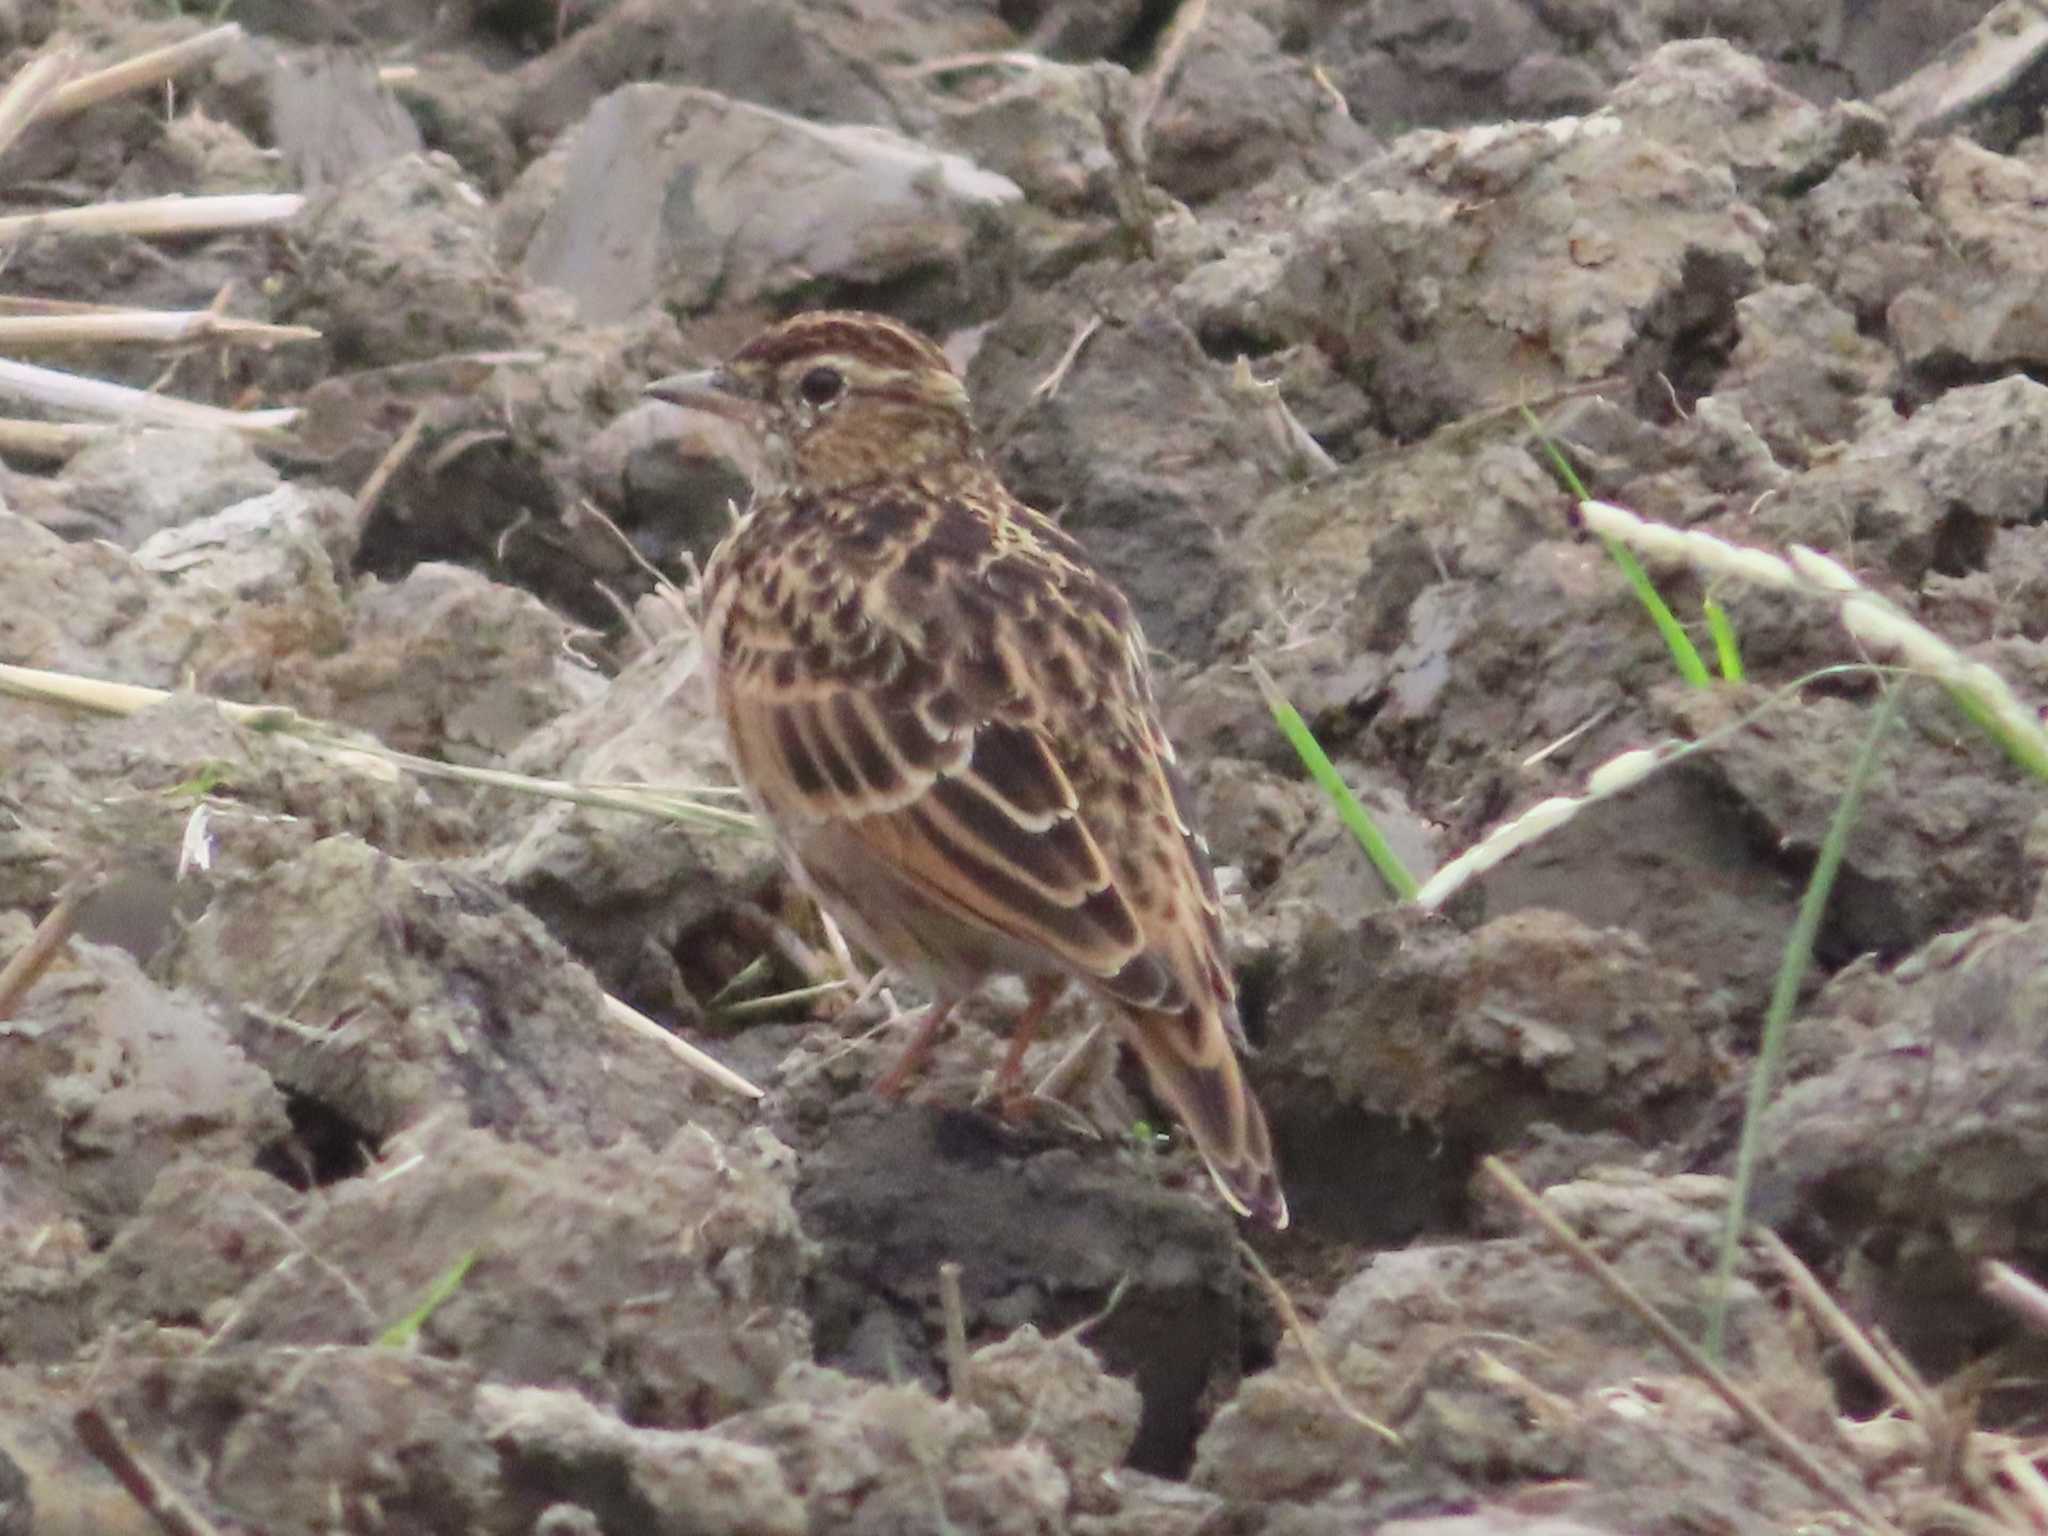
[1124,1008,1286,1229]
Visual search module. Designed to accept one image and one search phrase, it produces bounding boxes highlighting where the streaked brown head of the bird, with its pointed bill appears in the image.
[647,309,975,489]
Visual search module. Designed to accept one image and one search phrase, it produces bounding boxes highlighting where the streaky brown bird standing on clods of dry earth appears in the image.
[647,309,1288,1229]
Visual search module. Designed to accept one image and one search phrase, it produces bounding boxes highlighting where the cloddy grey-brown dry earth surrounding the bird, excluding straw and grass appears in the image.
[0,0,2048,1536]
